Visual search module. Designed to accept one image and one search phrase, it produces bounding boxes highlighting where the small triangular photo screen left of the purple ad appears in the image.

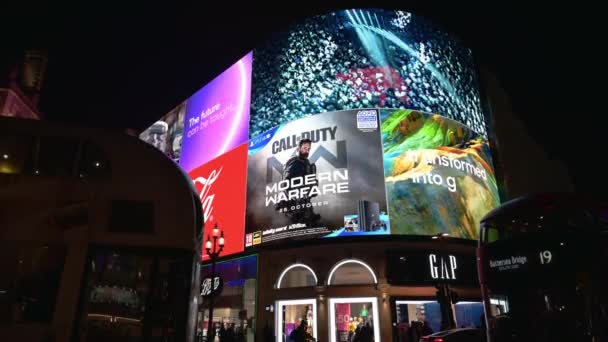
[139,102,186,162]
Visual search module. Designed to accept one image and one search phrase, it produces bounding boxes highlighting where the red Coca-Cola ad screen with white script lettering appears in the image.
[190,144,247,260]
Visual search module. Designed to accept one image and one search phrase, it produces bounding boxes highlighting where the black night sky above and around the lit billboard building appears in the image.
[0,0,608,194]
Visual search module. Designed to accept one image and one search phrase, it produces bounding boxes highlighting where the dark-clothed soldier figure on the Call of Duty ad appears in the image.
[276,139,321,227]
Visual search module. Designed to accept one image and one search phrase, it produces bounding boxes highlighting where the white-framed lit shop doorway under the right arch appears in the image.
[329,297,380,342]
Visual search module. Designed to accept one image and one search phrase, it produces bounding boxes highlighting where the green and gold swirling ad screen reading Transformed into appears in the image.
[380,109,500,239]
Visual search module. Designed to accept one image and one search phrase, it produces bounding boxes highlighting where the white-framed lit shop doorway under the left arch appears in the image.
[276,298,318,342]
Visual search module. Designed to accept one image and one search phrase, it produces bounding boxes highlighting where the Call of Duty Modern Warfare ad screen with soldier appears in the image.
[245,109,391,247]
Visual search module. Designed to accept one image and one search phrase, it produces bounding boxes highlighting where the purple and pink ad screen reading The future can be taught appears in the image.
[180,53,252,172]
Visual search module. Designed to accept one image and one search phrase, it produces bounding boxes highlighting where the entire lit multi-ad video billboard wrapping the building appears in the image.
[140,9,499,255]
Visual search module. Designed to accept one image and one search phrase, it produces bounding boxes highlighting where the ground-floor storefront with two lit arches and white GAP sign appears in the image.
[257,243,482,342]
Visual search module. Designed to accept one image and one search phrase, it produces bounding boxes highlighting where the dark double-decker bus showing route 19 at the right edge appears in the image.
[477,194,608,342]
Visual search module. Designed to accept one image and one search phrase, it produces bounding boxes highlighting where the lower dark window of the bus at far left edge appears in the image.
[0,243,66,324]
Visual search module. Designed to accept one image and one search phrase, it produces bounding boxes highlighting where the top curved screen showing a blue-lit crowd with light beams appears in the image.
[249,9,486,137]
